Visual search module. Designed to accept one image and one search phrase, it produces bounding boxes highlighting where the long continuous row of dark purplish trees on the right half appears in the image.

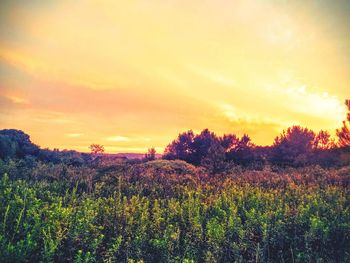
[163,100,350,172]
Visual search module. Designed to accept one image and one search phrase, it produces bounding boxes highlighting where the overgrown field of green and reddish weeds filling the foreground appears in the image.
[0,159,350,262]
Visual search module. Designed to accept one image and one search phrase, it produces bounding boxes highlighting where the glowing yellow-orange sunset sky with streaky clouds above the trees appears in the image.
[0,0,350,153]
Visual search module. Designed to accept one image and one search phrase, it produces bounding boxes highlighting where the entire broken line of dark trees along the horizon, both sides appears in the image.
[0,100,350,170]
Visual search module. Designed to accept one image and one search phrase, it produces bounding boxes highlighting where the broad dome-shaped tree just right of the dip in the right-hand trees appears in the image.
[270,126,315,166]
